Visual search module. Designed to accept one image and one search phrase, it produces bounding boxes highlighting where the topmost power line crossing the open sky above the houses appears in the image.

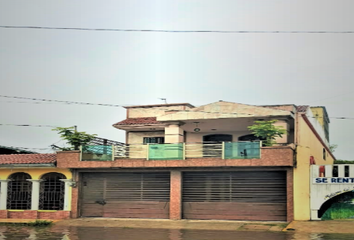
[0,26,354,34]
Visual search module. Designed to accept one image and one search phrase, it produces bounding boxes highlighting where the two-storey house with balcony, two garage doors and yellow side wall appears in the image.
[57,101,334,221]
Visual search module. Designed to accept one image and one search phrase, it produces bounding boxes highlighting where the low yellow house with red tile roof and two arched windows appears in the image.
[0,153,72,219]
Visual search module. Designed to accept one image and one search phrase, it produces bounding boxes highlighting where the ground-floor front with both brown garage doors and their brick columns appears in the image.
[71,167,293,222]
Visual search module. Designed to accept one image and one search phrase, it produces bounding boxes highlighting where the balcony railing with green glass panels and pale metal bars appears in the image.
[81,142,261,161]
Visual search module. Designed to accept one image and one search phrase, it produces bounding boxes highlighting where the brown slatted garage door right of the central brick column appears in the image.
[182,171,286,221]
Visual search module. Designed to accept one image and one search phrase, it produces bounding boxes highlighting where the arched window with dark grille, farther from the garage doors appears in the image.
[7,173,32,210]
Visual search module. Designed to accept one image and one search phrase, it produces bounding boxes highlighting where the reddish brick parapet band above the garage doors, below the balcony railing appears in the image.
[57,146,294,168]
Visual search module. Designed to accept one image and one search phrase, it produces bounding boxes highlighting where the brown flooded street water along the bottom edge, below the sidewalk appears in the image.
[0,225,353,240]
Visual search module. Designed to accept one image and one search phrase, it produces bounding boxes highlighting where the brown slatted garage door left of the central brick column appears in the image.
[80,173,170,218]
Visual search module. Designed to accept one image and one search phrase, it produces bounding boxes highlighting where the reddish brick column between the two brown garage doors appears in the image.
[170,171,182,220]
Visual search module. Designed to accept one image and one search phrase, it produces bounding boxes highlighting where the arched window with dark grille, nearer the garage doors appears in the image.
[39,173,66,210]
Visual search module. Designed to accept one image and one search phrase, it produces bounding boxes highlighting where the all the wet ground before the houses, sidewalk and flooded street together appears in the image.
[0,218,354,240]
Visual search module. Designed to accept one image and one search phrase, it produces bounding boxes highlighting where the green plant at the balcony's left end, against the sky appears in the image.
[52,127,97,151]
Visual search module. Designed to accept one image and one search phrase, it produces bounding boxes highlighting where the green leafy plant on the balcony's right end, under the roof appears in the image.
[247,119,286,146]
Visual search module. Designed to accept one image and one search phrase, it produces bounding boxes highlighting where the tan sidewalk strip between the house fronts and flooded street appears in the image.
[0,218,354,234]
